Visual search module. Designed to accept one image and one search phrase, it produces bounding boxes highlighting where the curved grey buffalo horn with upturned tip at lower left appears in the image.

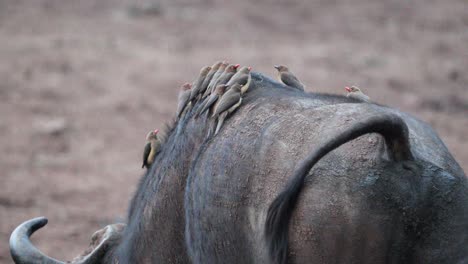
[10,217,64,264]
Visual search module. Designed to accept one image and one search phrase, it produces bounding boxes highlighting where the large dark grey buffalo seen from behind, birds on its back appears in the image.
[10,73,468,263]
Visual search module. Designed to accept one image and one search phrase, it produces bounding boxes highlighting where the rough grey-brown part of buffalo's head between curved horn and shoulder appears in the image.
[71,224,125,264]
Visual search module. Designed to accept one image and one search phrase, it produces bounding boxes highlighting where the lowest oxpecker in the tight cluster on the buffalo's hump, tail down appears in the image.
[212,83,242,135]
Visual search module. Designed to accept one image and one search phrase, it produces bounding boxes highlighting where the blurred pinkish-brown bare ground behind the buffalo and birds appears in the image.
[0,0,468,263]
